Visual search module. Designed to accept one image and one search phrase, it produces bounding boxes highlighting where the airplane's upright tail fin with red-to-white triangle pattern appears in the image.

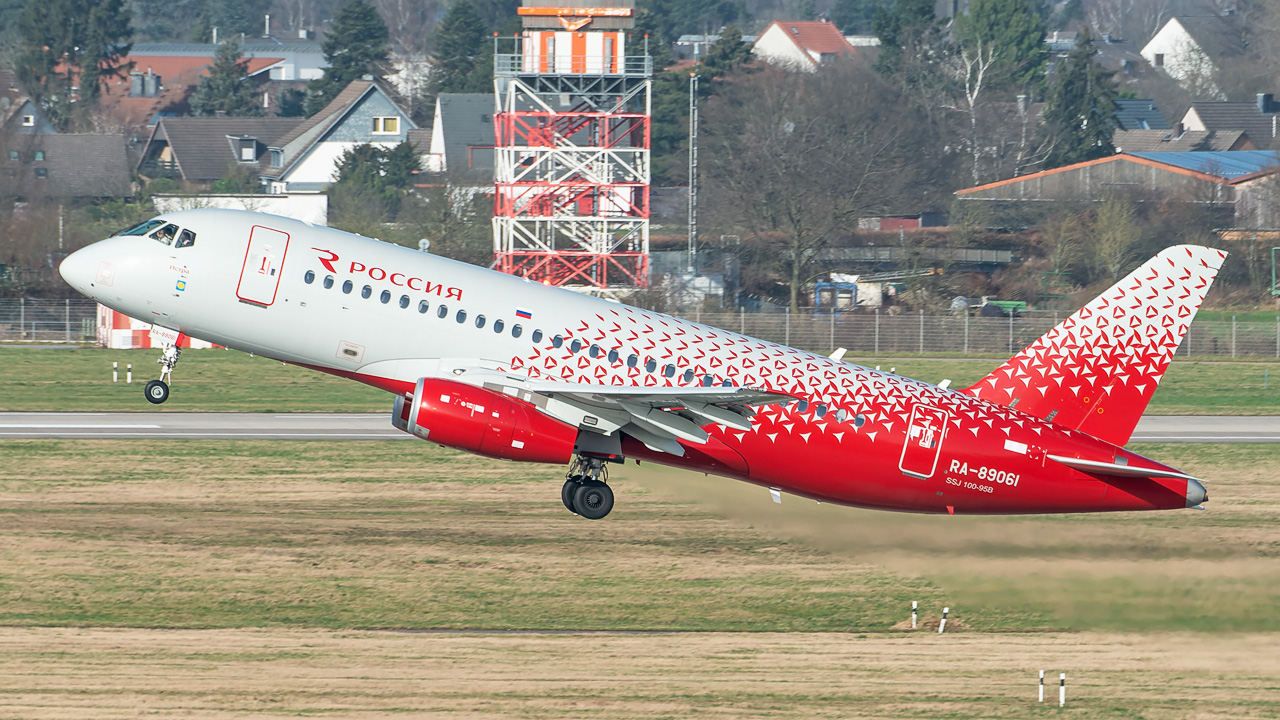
[965,245,1226,445]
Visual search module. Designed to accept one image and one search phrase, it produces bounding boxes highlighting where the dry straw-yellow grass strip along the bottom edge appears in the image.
[0,628,1280,720]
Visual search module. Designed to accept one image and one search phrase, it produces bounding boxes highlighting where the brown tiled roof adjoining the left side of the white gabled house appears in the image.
[143,118,298,182]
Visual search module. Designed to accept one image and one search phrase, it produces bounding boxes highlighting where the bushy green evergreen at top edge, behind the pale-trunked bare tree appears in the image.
[956,0,1048,90]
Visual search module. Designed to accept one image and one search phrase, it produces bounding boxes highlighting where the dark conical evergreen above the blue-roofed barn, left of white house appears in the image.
[1044,28,1117,168]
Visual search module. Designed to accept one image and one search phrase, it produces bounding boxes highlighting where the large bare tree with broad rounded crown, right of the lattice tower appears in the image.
[703,63,947,311]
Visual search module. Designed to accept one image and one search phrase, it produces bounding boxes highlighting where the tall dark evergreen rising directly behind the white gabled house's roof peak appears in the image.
[306,0,389,115]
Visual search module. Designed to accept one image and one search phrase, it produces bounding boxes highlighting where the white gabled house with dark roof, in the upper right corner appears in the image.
[1142,15,1244,97]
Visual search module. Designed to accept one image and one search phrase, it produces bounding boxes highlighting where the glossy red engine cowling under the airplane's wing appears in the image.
[392,378,577,464]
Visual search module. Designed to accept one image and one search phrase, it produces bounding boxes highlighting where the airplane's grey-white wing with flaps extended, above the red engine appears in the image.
[437,369,795,456]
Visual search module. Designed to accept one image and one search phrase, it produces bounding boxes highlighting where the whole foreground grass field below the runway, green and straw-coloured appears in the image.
[0,441,1280,719]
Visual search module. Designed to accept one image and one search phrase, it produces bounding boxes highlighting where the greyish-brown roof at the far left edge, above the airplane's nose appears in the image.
[0,135,133,197]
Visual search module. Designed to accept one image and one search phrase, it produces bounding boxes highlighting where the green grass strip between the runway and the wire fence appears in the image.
[0,347,1280,415]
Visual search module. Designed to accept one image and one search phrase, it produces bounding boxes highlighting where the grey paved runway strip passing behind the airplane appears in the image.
[0,413,1280,442]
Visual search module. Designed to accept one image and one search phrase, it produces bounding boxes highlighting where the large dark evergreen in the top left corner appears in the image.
[15,0,132,129]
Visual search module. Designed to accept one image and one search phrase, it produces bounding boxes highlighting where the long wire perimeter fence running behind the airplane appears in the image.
[0,297,1280,359]
